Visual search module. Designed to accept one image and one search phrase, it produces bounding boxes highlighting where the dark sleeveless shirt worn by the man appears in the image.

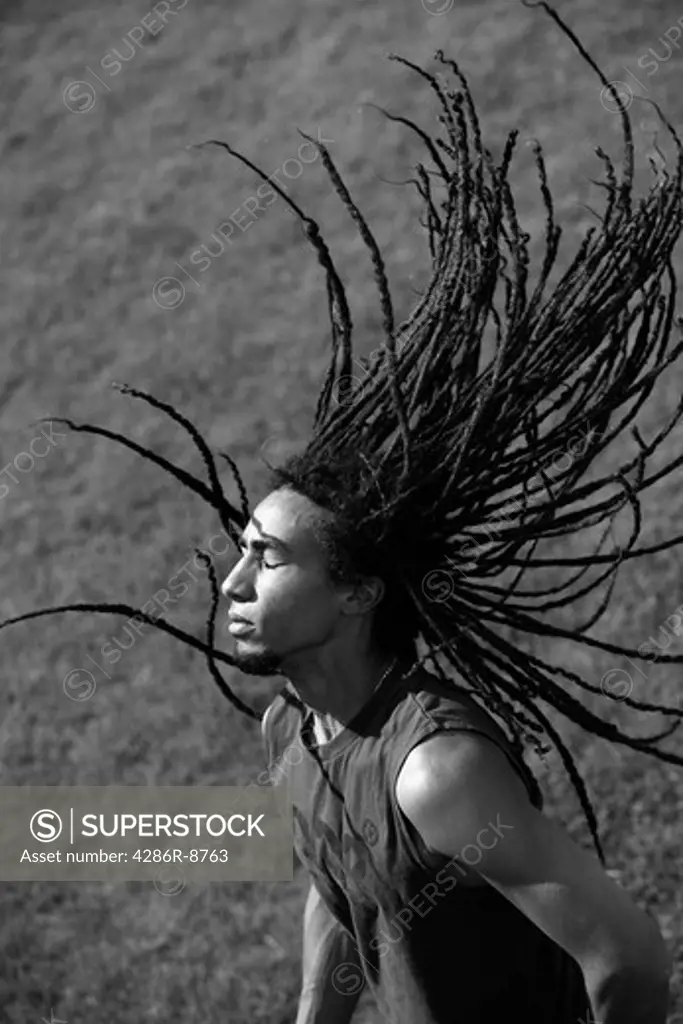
[264,664,591,1024]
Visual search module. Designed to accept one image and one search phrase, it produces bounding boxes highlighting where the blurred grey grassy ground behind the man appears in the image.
[0,0,683,1024]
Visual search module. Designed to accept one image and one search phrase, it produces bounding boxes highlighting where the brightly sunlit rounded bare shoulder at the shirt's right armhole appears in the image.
[396,731,538,855]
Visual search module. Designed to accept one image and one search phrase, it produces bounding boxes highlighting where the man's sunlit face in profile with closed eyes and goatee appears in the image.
[221,488,358,676]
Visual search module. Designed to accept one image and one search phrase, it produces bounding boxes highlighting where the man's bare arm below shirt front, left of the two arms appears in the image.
[296,885,362,1024]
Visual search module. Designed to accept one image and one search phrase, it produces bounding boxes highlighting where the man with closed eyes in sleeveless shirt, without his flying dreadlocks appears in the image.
[222,487,670,1024]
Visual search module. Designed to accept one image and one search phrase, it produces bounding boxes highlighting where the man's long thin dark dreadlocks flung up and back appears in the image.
[0,0,683,863]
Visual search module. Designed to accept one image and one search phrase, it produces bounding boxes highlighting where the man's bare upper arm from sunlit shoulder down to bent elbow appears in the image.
[396,733,666,968]
